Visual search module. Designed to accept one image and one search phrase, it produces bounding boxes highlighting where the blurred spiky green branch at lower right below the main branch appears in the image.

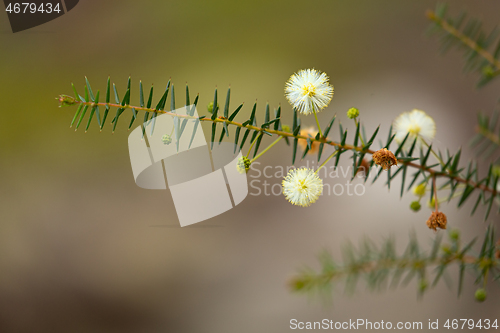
[289,227,500,296]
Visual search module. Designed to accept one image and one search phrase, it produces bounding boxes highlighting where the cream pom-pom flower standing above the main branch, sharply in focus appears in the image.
[285,69,333,115]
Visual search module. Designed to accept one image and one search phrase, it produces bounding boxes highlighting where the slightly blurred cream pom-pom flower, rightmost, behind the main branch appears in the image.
[393,109,436,147]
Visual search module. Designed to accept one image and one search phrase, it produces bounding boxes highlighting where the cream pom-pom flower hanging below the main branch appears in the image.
[282,168,323,207]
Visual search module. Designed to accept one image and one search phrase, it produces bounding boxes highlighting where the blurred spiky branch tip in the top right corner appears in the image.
[427,3,500,87]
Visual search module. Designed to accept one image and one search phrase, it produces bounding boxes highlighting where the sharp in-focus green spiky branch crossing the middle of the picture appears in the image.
[59,78,499,219]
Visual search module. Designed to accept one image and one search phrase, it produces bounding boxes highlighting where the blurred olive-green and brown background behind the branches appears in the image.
[0,0,500,333]
